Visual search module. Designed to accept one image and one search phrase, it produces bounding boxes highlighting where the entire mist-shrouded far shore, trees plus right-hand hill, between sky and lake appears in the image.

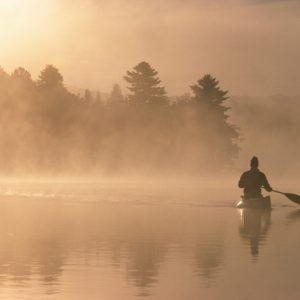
[0,62,300,180]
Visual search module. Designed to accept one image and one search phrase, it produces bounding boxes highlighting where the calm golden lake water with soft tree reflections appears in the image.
[0,182,300,300]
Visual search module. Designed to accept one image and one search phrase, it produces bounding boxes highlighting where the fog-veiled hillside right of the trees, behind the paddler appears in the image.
[230,95,300,180]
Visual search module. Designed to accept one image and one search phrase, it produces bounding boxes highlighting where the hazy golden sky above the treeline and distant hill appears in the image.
[0,0,300,95]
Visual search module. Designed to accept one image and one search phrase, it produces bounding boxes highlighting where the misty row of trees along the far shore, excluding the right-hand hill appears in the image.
[0,62,239,174]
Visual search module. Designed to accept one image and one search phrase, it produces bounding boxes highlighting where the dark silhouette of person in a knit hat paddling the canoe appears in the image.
[239,156,272,198]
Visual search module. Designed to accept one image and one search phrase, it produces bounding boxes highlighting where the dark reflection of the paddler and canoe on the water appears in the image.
[239,208,271,257]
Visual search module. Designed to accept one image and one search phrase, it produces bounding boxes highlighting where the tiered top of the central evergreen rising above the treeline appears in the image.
[124,62,167,105]
